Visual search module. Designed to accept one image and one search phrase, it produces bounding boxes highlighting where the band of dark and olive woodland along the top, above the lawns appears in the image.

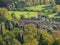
[0,0,55,10]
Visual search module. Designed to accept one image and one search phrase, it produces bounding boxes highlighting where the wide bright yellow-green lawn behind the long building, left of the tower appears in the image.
[7,11,37,20]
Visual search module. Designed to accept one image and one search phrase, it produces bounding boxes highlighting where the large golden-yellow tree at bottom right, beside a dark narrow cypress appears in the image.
[39,30,54,45]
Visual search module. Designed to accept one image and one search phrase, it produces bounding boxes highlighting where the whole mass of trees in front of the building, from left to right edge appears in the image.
[0,9,60,45]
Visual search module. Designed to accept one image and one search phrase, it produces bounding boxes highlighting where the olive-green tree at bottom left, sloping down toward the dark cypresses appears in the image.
[4,34,21,45]
